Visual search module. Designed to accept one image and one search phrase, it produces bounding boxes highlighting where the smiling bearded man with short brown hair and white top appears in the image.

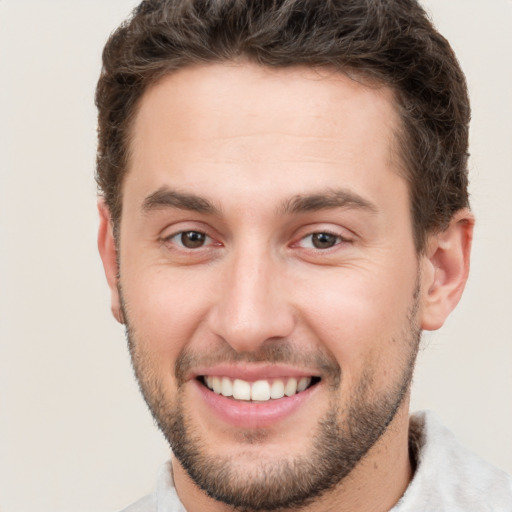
[97,0,512,512]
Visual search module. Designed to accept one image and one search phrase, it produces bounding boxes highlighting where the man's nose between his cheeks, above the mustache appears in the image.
[209,244,295,352]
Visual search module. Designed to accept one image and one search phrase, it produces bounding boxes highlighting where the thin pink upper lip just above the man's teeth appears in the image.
[189,363,319,382]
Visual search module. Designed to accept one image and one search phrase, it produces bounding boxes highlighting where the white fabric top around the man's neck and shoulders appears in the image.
[123,412,512,512]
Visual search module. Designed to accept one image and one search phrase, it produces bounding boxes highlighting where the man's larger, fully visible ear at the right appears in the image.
[421,208,475,331]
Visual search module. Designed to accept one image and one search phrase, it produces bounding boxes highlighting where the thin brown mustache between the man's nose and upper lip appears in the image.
[174,340,341,386]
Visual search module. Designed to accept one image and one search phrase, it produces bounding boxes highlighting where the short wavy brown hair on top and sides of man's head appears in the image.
[96,0,470,251]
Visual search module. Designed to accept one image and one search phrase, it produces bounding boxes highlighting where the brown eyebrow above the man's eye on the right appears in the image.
[282,189,378,214]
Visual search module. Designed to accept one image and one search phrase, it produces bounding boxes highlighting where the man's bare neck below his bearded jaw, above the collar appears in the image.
[172,397,412,512]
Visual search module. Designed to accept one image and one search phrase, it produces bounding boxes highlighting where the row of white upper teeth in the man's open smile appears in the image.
[204,376,311,402]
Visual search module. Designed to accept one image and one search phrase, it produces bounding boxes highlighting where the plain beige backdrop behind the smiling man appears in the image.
[0,0,512,512]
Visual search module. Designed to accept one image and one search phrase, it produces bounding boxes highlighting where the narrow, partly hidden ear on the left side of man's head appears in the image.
[98,198,124,324]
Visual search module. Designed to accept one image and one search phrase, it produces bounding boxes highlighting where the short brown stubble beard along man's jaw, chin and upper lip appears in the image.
[123,288,421,511]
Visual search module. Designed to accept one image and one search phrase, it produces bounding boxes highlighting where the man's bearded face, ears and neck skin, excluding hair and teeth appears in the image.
[99,63,473,512]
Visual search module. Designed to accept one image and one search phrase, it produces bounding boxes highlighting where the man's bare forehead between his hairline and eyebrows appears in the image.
[125,63,406,214]
